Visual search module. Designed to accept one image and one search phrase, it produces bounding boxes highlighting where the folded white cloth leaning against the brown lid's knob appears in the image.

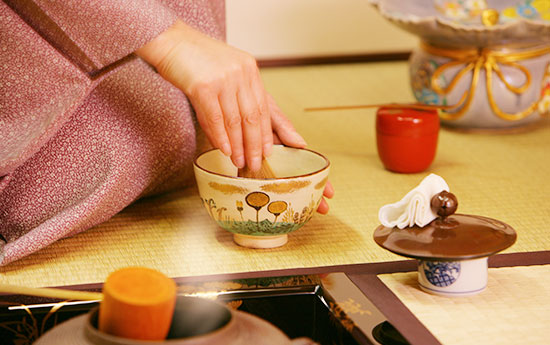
[378,174,449,229]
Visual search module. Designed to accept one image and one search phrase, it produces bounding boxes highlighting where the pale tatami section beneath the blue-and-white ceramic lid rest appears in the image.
[378,265,550,345]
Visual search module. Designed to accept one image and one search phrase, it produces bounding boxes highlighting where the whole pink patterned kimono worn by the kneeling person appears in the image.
[0,0,225,265]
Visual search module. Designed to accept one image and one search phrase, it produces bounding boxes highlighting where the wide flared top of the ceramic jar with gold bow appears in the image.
[370,0,550,48]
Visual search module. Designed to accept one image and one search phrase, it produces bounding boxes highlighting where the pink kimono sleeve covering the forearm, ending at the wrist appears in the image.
[4,0,177,76]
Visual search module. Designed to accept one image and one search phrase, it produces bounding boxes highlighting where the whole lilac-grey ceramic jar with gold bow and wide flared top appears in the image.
[371,0,550,129]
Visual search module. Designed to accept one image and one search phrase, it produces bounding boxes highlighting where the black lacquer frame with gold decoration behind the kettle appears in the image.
[0,274,402,345]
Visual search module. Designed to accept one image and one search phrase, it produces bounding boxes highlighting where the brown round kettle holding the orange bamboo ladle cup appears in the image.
[35,296,314,345]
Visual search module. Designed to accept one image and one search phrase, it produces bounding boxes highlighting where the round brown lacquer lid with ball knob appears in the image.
[374,192,517,260]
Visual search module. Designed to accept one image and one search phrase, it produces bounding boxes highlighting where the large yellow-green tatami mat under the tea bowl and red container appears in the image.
[0,62,550,286]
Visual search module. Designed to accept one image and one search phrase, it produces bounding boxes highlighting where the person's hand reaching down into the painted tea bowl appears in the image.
[136,21,305,171]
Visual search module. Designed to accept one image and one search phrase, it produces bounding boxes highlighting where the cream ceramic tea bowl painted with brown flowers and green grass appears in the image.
[194,145,330,248]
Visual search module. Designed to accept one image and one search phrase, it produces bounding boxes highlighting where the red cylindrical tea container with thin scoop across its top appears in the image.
[376,107,439,173]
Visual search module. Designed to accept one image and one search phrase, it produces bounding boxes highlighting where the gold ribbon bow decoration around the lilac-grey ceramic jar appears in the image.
[421,42,550,121]
